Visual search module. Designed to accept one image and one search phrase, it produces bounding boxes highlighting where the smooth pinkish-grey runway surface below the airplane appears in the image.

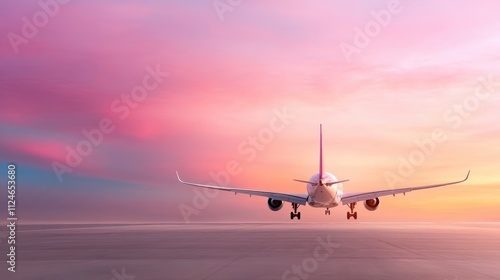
[0,222,500,280]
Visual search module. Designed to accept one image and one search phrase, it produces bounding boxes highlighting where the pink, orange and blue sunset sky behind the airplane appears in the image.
[0,0,500,222]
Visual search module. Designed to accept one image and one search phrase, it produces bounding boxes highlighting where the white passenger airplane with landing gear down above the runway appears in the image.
[176,124,470,220]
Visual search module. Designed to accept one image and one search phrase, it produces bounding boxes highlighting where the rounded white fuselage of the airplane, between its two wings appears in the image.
[307,172,344,208]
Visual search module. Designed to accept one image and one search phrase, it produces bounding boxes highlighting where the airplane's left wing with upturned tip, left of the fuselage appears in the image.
[175,171,308,205]
